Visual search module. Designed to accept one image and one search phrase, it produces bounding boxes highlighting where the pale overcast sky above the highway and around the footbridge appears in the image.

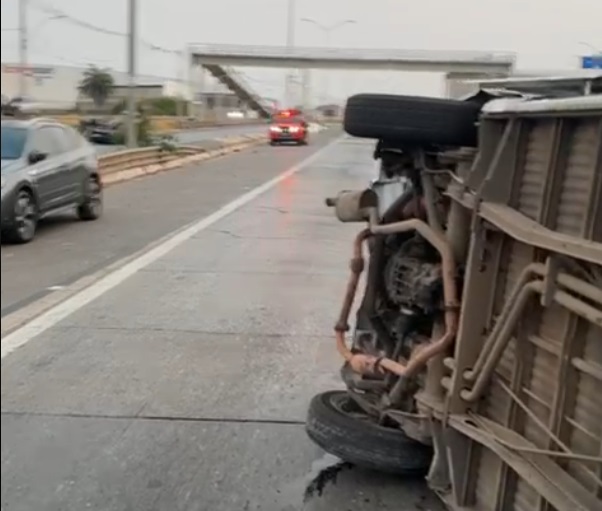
[1,0,602,103]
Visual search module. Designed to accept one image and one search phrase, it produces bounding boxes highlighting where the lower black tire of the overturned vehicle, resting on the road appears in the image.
[306,391,433,476]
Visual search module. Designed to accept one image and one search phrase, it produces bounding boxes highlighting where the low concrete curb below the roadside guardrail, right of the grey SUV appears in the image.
[102,134,267,186]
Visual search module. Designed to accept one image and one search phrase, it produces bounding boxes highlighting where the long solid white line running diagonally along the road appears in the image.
[1,137,342,360]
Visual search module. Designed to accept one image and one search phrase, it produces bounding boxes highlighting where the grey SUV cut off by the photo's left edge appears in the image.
[0,119,102,243]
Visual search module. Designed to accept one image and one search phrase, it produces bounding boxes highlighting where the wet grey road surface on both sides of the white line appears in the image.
[1,134,440,511]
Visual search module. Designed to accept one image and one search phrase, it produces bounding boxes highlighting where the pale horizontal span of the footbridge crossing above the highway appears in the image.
[190,44,516,66]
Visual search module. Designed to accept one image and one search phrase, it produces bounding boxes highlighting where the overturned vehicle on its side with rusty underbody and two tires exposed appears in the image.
[306,74,602,511]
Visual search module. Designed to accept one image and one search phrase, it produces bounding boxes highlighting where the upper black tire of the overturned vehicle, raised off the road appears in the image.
[344,94,481,147]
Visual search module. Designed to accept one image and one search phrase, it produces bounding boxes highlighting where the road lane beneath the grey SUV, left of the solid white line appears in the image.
[1,130,333,317]
